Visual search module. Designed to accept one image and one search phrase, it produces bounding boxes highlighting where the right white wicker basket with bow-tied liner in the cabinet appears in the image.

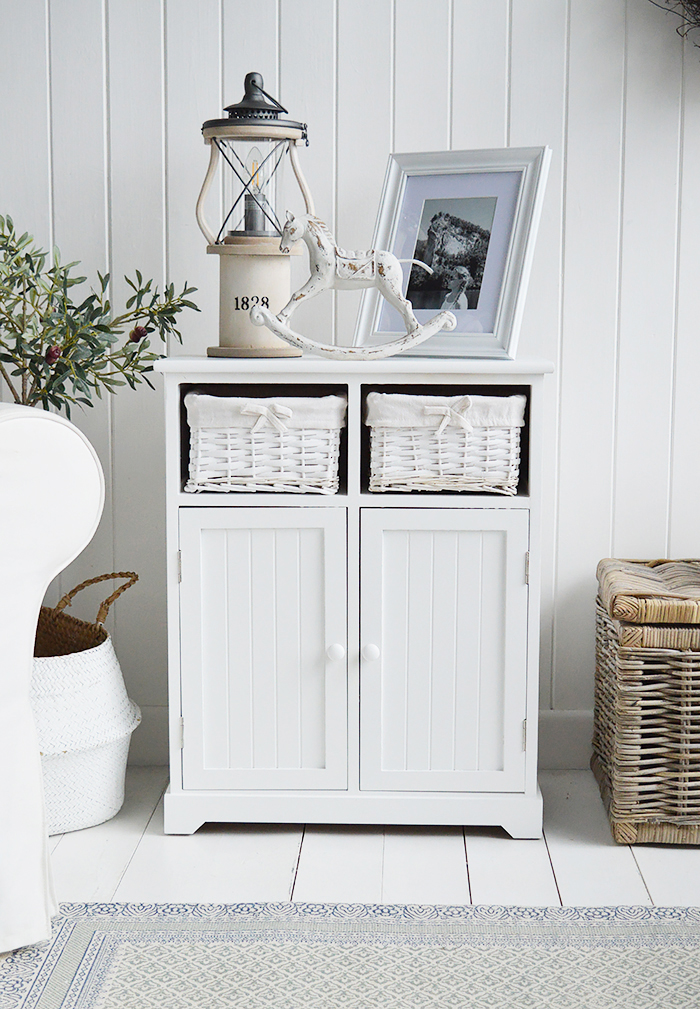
[366,393,526,494]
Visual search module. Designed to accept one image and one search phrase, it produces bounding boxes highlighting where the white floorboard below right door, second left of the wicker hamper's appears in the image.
[381,826,470,904]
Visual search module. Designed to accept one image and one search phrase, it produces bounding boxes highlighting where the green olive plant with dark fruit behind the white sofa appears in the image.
[0,215,199,417]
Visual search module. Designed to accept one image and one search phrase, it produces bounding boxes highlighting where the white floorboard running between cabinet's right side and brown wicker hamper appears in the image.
[540,771,652,907]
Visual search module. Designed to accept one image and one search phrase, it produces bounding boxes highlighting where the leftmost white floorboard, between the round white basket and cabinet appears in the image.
[51,767,167,903]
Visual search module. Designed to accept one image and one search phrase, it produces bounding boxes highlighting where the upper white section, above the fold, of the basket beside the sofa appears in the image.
[30,638,141,755]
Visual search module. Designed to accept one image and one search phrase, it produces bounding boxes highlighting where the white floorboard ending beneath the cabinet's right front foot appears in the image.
[464,827,560,907]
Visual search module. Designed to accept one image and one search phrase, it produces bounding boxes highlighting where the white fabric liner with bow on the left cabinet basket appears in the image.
[185,393,347,431]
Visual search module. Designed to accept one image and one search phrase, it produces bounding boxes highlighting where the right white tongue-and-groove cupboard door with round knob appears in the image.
[360,509,529,791]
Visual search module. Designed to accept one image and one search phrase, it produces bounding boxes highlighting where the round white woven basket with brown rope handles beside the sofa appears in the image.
[31,571,141,834]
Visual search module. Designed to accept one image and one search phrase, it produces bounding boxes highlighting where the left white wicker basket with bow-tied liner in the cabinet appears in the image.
[185,393,347,494]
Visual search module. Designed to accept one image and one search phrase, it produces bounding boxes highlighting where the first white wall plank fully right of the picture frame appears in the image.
[556,0,625,709]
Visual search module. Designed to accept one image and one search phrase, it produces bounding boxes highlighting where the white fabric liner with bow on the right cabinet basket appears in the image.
[366,393,527,431]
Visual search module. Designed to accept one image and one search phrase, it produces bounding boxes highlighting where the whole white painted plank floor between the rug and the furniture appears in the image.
[50,767,700,906]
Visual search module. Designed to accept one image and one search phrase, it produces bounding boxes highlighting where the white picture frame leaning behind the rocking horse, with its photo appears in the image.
[354,147,552,359]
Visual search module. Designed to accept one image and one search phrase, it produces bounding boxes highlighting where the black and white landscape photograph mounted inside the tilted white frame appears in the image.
[406,197,496,311]
